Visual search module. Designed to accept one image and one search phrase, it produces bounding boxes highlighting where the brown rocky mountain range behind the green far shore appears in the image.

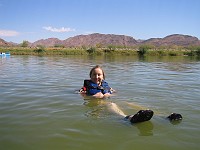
[0,33,200,47]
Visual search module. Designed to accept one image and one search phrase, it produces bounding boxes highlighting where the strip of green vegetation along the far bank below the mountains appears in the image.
[0,44,200,57]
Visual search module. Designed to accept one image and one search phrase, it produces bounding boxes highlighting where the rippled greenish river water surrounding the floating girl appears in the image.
[0,56,200,150]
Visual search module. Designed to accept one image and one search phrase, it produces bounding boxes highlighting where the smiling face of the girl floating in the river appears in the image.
[91,68,103,85]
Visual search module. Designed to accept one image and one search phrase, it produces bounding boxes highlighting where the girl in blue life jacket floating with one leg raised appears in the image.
[80,65,154,123]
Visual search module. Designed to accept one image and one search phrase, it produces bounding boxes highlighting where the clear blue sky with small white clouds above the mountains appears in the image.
[0,0,200,43]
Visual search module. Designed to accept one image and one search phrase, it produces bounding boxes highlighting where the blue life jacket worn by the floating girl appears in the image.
[83,80,112,95]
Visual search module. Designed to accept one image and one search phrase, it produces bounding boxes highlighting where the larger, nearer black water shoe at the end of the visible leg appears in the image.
[125,110,154,123]
